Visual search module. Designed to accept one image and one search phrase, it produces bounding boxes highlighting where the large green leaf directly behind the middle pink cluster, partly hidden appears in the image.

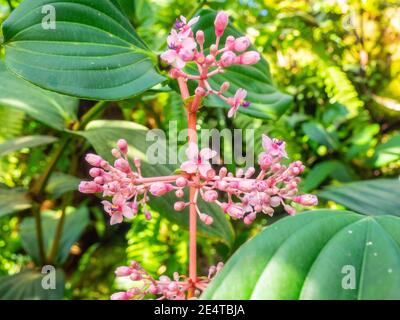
[79,120,234,244]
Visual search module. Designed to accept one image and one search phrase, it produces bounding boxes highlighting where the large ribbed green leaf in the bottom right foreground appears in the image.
[203,210,400,300]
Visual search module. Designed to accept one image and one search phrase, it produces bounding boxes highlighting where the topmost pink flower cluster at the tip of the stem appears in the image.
[161,11,260,117]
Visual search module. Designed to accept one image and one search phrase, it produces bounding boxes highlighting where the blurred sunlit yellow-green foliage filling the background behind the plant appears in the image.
[0,0,400,299]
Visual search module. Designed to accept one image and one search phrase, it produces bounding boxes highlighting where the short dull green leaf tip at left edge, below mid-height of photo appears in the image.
[0,188,31,217]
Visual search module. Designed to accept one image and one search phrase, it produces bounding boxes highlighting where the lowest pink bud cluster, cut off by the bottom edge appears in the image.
[111,261,223,300]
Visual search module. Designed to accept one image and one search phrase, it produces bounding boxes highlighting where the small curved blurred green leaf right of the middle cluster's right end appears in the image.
[301,160,353,192]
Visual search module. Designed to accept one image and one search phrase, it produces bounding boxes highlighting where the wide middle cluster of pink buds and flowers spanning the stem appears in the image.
[79,135,318,224]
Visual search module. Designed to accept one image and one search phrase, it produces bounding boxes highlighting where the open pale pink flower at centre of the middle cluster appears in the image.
[181,143,217,177]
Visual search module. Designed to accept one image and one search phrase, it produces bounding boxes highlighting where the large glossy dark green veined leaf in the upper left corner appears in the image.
[3,0,163,100]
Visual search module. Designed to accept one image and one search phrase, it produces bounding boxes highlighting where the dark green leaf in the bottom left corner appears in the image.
[0,269,65,300]
